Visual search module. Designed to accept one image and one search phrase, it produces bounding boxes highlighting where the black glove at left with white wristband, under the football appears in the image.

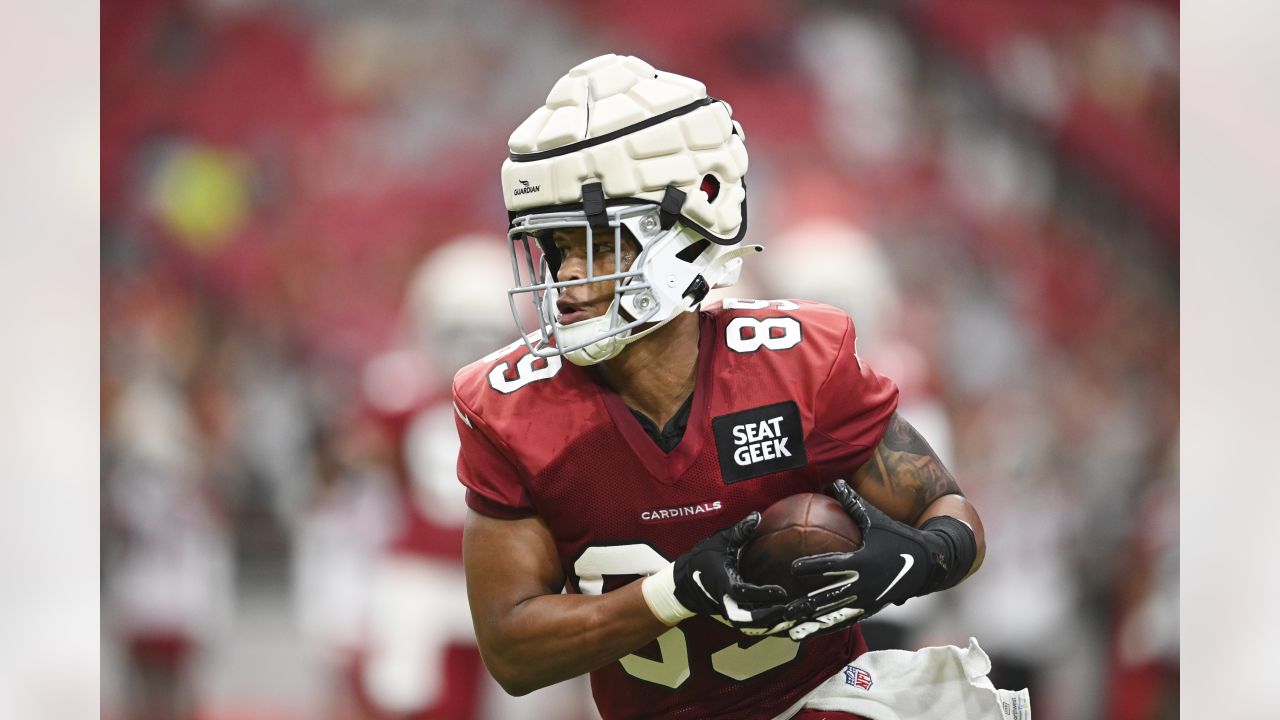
[641,512,791,634]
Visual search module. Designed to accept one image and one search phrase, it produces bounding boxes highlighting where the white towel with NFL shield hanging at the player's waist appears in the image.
[778,638,1032,720]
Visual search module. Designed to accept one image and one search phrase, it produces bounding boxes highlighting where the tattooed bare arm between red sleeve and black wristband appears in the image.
[850,413,987,577]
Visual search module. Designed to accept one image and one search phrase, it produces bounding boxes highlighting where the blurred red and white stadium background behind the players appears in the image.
[101,0,1179,720]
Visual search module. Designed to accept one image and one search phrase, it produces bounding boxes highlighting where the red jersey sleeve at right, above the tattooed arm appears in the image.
[814,313,897,474]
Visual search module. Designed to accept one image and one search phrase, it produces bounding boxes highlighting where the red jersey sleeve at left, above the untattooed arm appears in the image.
[453,395,536,520]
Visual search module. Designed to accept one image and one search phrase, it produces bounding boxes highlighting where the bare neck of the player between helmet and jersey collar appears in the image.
[599,311,698,428]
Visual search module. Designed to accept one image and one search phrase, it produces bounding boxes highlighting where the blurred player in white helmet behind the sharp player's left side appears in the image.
[353,234,586,720]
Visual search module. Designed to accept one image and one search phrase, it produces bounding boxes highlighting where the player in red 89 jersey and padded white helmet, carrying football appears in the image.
[453,55,1029,720]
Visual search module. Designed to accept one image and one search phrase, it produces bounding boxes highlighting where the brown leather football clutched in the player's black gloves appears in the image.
[740,492,863,597]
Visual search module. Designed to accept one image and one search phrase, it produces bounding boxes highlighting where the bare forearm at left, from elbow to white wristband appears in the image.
[481,573,669,696]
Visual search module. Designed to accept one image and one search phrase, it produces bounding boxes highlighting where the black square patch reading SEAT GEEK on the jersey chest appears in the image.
[712,401,809,486]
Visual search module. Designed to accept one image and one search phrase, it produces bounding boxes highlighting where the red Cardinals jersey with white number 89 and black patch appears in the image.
[453,300,897,720]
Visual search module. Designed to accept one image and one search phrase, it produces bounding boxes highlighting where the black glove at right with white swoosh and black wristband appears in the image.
[790,480,978,641]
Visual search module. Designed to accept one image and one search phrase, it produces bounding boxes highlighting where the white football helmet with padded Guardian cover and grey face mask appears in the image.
[502,55,762,365]
